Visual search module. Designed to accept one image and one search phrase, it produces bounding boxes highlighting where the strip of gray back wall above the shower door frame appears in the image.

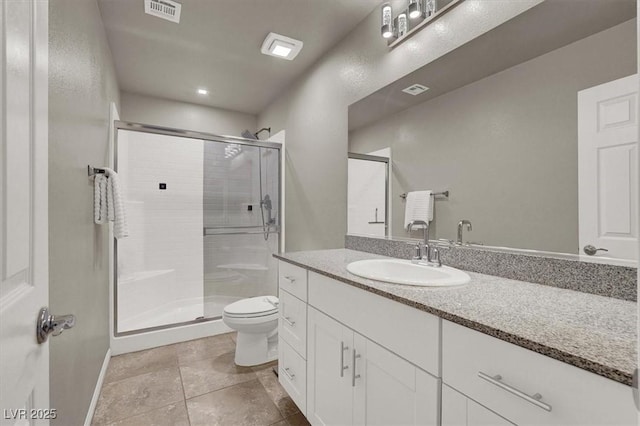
[120,92,256,137]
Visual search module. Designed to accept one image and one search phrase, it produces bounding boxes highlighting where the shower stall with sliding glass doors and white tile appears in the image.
[113,121,281,338]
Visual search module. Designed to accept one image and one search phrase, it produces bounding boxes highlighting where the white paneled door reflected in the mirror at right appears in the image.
[578,75,638,260]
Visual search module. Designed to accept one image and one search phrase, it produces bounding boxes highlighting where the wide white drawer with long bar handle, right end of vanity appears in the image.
[442,321,636,425]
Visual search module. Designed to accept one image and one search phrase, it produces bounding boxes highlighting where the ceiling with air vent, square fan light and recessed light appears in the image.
[98,0,380,114]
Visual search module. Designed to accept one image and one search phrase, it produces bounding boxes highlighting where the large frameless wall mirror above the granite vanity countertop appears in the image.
[348,0,639,260]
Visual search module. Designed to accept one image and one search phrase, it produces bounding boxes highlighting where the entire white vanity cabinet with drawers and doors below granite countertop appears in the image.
[279,262,637,426]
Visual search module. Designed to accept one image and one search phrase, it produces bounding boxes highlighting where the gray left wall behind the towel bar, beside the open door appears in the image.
[49,0,119,425]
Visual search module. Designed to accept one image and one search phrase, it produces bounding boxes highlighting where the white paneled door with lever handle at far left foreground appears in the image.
[0,0,50,424]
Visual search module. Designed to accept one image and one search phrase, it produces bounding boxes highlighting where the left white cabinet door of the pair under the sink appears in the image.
[307,307,353,426]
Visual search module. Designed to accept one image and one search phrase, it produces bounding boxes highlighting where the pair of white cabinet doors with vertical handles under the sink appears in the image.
[307,307,440,425]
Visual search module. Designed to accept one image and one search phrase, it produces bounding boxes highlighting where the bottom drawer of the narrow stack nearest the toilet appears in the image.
[278,340,307,415]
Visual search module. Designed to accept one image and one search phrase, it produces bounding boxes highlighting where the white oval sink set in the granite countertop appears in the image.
[347,259,471,287]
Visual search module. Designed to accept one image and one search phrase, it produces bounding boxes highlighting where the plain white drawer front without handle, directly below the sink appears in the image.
[309,272,440,377]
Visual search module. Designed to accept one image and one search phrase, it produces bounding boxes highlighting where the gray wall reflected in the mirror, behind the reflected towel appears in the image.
[349,19,636,253]
